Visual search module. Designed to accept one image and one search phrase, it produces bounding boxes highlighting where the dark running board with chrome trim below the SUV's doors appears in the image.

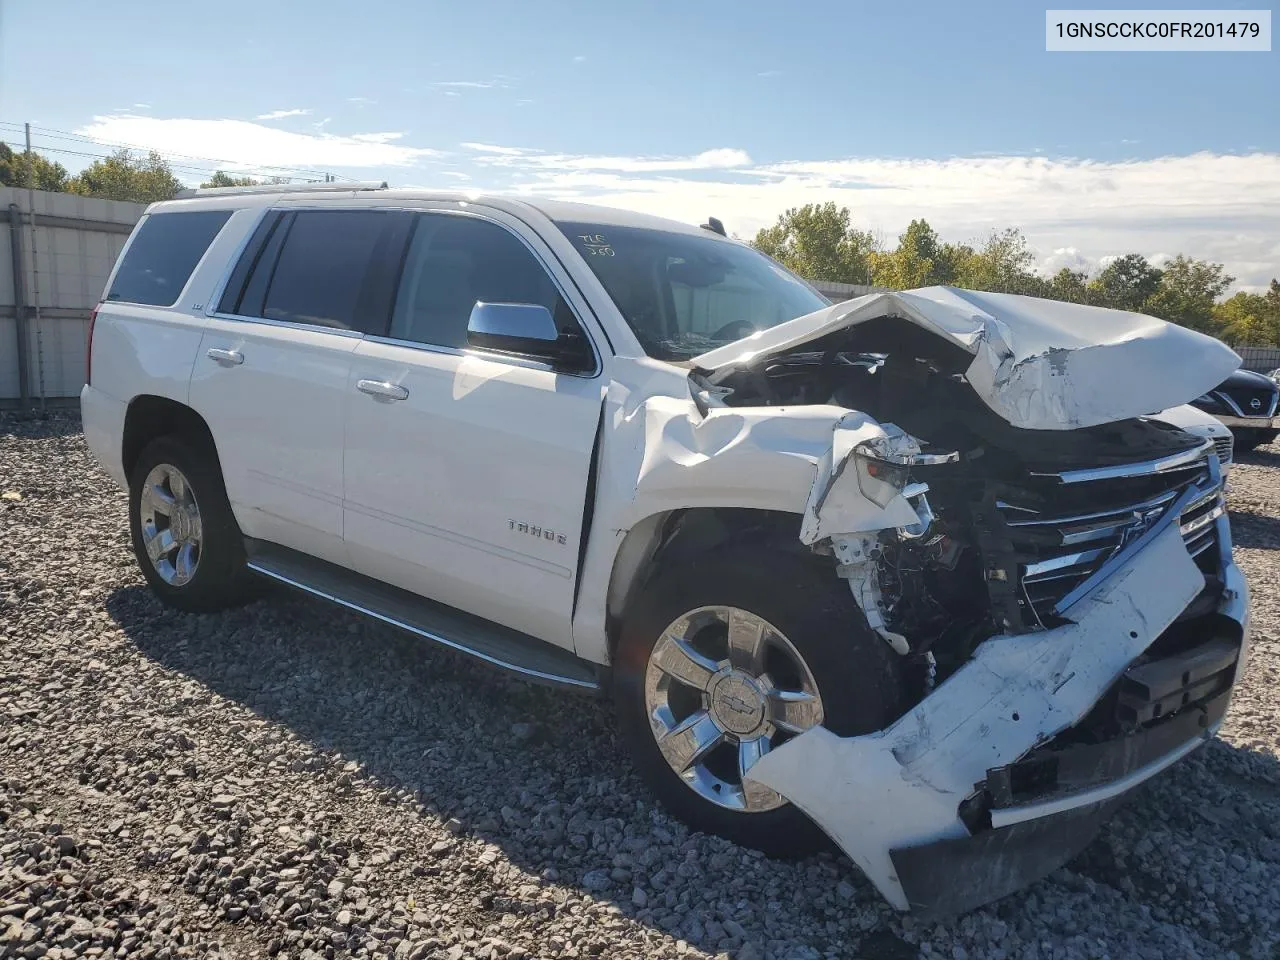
[244,538,603,692]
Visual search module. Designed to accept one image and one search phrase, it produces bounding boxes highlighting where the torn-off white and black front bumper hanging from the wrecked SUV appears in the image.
[750,517,1248,915]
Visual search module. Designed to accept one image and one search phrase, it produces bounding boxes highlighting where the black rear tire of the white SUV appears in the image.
[129,435,253,613]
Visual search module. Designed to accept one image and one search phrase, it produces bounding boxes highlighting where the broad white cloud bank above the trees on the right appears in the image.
[475,145,1280,288]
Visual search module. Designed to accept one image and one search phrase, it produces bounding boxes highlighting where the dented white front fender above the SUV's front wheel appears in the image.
[573,358,918,663]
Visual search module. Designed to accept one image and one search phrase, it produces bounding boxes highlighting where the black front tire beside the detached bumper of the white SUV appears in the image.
[613,544,908,858]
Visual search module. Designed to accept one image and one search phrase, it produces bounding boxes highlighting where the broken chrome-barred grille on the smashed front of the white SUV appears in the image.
[996,440,1225,626]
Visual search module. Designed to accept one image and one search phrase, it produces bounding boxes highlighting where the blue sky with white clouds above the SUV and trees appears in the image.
[0,0,1280,285]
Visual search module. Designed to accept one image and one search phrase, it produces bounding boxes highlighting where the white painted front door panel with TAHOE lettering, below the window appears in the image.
[344,340,603,648]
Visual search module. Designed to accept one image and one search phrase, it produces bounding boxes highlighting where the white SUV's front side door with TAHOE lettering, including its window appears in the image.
[343,212,603,648]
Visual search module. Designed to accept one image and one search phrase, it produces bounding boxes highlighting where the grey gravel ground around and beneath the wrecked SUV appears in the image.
[0,415,1280,960]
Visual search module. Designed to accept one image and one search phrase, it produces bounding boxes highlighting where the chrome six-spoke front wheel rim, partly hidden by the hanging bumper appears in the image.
[644,607,823,813]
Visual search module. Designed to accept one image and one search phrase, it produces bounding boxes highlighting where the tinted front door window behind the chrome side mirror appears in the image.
[390,214,579,348]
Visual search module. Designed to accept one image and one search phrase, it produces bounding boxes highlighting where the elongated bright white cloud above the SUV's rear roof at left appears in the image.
[76,115,439,168]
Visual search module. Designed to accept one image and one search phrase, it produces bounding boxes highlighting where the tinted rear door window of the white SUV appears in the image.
[259,210,392,333]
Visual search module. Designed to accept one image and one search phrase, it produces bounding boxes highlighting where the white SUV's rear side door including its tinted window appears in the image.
[191,209,403,563]
